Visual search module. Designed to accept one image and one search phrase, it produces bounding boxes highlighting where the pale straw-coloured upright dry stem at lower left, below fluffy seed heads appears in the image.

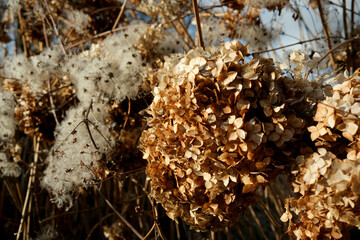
[16,136,40,240]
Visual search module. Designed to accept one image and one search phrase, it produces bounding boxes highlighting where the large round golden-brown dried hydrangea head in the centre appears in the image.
[141,41,309,230]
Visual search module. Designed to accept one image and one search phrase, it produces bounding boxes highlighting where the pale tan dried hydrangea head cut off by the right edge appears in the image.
[282,70,360,239]
